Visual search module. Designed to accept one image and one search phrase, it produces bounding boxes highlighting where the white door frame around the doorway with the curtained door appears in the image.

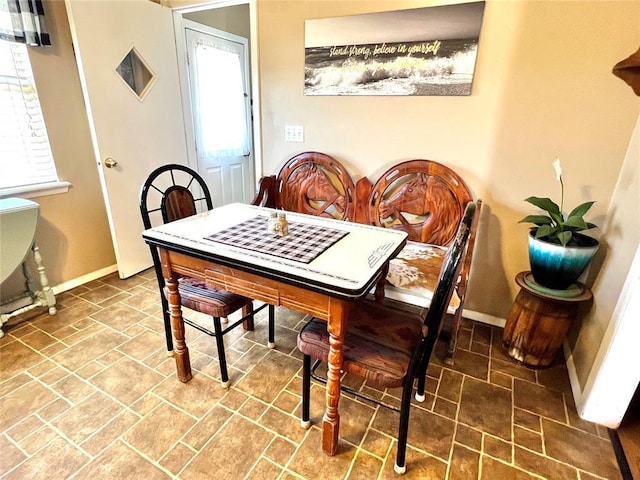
[173,0,263,186]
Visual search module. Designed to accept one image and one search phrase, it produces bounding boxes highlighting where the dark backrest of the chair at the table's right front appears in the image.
[407,202,477,379]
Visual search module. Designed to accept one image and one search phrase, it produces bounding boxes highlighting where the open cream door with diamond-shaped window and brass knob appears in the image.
[65,0,187,278]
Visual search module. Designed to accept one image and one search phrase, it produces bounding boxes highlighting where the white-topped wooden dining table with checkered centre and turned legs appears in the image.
[142,203,407,455]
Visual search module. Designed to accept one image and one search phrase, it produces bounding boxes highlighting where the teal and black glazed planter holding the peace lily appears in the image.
[529,233,599,290]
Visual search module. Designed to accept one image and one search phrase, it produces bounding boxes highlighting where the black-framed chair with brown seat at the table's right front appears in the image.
[298,202,476,474]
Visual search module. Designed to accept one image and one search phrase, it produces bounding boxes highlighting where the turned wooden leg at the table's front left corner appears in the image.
[160,250,193,383]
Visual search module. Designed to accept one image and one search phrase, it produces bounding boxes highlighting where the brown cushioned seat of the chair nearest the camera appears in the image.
[298,301,423,389]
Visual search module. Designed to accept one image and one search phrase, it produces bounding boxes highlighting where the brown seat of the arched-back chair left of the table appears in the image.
[164,277,251,317]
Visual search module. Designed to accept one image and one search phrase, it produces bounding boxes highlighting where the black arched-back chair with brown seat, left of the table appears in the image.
[140,164,275,388]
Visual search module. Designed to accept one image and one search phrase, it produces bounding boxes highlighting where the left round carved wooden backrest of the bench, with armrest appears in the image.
[252,152,356,221]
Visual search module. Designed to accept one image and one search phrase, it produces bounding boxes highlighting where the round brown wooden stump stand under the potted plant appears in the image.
[502,272,592,368]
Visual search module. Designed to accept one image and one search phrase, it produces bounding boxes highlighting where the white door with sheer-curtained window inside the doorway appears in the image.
[183,20,255,207]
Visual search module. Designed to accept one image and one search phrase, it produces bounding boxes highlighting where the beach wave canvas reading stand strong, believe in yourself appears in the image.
[304,2,485,95]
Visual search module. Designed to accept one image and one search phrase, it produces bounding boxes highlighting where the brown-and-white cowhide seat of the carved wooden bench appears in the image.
[385,242,460,313]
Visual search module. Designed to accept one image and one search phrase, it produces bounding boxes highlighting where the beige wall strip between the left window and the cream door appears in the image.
[2,1,115,298]
